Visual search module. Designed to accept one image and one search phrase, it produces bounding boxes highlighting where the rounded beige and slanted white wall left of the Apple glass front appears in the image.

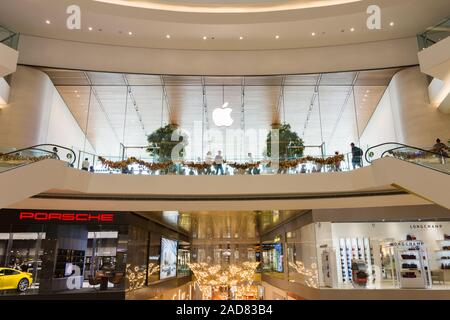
[0,66,94,152]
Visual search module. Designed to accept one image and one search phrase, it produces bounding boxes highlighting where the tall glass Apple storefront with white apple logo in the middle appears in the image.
[42,68,399,174]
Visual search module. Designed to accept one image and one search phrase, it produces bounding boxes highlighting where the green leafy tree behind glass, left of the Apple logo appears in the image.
[147,124,187,162]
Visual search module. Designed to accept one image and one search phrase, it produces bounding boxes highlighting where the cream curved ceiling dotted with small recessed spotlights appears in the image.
[0,0,450,50]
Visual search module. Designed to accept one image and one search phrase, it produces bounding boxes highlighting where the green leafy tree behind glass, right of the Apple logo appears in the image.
[266,123,304,161]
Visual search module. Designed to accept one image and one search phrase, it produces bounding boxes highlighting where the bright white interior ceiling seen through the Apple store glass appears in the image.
[43,69,398,160]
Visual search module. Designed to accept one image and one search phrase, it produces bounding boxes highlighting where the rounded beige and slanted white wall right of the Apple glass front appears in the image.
[360,67,450,148]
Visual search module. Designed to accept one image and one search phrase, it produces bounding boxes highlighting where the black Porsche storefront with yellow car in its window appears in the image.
[0,210,130,298]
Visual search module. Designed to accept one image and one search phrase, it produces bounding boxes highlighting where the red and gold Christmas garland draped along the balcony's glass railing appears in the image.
[98,154,344,171]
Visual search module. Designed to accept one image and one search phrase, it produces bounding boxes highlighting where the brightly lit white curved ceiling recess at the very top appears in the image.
[94,0,362,13]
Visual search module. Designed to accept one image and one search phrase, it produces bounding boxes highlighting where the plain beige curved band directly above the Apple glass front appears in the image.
[19,35,418,76]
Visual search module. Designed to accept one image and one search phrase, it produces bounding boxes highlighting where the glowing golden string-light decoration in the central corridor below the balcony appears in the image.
[188,261,259,300]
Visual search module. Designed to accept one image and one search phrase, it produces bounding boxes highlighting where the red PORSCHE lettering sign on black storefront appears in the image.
[19,211,114,222]
